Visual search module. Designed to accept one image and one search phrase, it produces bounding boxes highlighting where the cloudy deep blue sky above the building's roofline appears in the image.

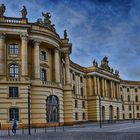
[0,0,140,81]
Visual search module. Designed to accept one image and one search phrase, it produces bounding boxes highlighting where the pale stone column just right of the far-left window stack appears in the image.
[21,35,28,76]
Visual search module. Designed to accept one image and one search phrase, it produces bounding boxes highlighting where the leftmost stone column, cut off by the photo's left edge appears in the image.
[0,33,5,76]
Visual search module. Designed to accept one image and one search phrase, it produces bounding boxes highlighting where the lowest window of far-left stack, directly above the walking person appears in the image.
[9,108,19,121]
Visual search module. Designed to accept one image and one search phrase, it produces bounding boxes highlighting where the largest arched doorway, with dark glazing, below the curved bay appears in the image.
[46,95,59,122]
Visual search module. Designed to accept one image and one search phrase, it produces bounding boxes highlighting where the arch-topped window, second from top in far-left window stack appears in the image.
[10,64,19,78]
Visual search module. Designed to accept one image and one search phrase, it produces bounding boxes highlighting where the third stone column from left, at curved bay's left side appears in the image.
[34,41,40,79]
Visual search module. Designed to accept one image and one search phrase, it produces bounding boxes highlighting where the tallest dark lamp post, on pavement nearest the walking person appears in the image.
[28,87,31,135]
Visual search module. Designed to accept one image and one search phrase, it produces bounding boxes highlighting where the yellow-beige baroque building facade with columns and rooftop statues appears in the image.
[0,6,140,129]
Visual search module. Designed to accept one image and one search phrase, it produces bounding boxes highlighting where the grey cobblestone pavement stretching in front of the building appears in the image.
[0,121,140,140]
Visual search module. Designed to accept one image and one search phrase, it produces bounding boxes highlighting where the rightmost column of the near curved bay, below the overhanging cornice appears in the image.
[65,53,71,84]
